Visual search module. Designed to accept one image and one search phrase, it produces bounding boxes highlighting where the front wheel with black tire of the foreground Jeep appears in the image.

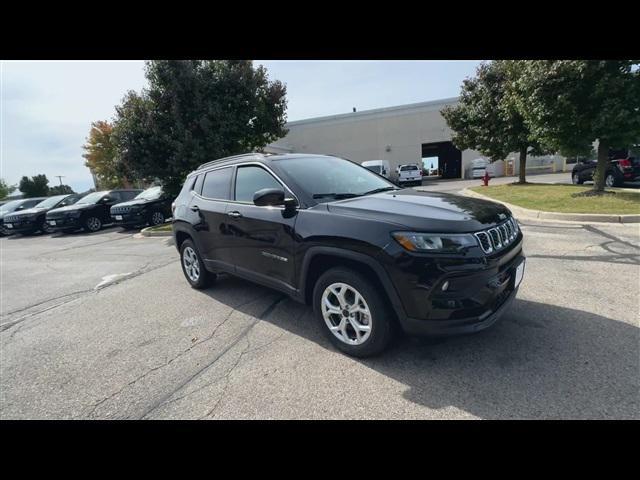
[313,267,394,357]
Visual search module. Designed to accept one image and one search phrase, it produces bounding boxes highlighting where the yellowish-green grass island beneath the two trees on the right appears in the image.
[471,183,640,215]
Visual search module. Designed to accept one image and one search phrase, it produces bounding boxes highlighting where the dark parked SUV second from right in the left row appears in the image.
[47,190,142,233]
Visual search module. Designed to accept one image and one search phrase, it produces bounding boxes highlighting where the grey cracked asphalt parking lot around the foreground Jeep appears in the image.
[0,203,640,419]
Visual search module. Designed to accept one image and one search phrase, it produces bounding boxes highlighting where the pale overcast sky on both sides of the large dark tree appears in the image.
[0,60,479,191]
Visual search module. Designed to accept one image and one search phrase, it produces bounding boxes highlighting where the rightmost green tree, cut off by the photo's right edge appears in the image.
[517,60,640,193]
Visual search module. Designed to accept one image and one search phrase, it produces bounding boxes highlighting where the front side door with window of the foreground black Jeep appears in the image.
[227,164,297,292]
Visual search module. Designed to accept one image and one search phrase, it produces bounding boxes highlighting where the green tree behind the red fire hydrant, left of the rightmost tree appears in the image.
[442,60,548,183]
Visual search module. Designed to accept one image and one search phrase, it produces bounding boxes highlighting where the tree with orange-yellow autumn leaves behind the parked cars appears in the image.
[82,120,131,189]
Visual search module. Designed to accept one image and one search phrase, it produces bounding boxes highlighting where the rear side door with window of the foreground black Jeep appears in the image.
[194,167,234,272]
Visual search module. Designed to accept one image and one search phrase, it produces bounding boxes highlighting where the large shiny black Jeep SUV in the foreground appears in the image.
[173,154,524,356]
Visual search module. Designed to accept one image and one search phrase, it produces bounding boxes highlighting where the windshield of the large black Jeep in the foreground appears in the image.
[278,157,396,201]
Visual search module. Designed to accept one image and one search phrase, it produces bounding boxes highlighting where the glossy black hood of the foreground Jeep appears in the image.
[327,188,511,233]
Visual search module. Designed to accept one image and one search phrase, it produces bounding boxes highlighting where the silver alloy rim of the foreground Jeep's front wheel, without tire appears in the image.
[320,283,371,345]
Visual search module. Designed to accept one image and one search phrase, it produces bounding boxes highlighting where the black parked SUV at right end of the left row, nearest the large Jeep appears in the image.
[111,187,173,229]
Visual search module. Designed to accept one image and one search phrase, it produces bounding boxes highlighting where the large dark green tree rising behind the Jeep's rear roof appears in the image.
[114,60,286,192]
